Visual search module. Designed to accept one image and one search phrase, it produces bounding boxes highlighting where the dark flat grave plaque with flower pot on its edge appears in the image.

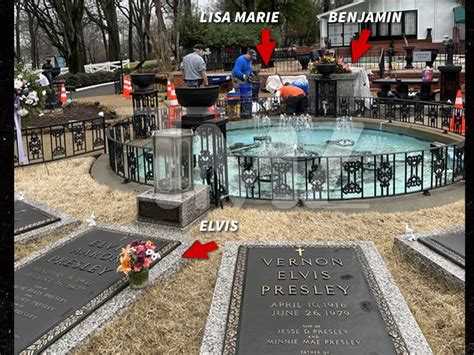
[15,228,180,354]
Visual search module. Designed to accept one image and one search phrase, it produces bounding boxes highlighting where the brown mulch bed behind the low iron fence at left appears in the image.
[28,103,113,128]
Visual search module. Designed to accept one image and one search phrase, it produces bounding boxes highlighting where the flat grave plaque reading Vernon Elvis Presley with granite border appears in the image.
[201,244,431,355]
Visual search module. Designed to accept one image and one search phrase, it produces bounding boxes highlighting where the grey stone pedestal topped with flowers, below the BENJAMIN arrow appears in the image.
[306,73,357,115]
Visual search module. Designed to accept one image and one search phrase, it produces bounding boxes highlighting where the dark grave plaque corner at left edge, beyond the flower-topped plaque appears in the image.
[14,200,60,235]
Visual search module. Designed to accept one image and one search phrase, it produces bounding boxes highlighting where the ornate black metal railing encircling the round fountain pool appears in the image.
[107,97,464,200]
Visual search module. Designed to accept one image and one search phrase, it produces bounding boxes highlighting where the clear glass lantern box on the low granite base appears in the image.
[153,128,193,194]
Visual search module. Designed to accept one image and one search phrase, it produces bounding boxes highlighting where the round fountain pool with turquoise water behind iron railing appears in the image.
[129,117,463,200]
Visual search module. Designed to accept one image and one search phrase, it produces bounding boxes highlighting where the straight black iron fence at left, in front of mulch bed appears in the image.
[14,117,106,167]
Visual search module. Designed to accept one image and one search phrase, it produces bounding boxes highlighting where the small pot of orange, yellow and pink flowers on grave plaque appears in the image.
[117,240,160,289]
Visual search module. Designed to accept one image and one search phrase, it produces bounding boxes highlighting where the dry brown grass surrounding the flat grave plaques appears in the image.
[16,158,464,355]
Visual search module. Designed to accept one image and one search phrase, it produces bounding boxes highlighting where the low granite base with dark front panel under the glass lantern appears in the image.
[137,185,210,228]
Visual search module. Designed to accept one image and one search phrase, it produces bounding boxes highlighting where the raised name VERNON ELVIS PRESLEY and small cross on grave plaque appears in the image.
[260,258,350,296]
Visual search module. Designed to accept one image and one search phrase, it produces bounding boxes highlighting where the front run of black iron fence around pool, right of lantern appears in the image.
[228,142,464,200]
